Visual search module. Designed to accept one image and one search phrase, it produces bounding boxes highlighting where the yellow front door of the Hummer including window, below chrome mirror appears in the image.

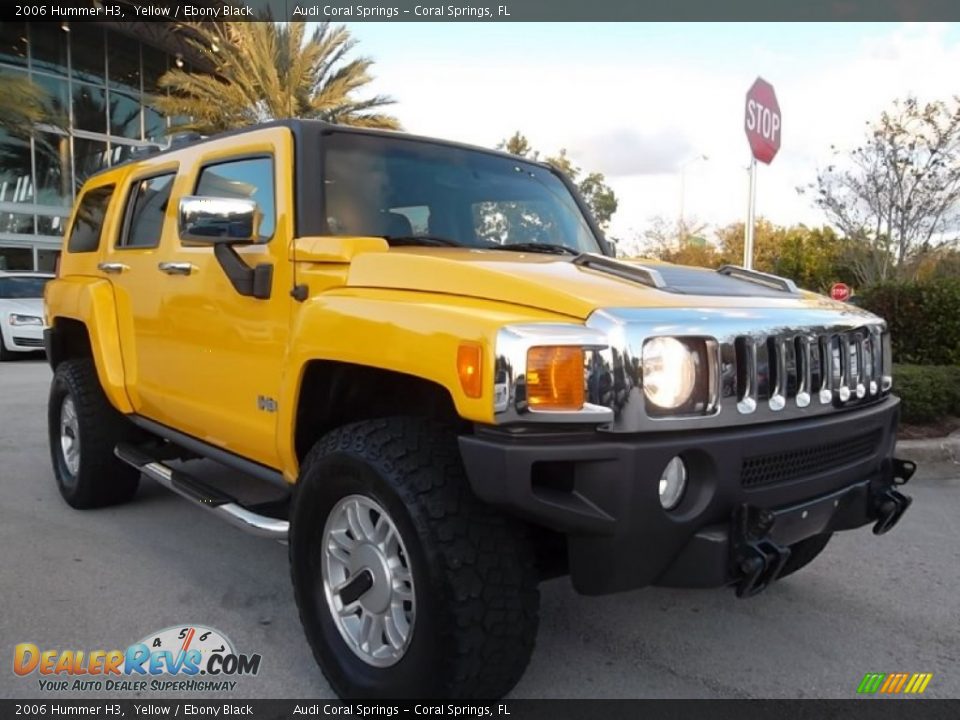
[148,149,293,467]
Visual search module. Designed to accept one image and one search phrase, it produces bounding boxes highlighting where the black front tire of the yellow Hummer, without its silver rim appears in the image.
[290,418,540,698]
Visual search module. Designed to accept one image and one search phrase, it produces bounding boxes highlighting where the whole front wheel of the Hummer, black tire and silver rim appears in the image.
[290,418,539,698]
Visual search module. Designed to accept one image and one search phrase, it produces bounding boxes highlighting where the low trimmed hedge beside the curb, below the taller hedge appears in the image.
[893,365,960,423]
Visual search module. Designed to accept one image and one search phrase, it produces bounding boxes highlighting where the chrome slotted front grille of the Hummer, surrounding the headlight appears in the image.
[587,307,892,432]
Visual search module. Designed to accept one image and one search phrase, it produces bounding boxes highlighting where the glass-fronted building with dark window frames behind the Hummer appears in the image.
[0,22,182,270]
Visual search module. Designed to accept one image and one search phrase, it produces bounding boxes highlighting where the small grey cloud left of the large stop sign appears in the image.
[570,128,693,177]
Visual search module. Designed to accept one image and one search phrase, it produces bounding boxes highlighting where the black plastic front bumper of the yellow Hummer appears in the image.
[460,397,912,594]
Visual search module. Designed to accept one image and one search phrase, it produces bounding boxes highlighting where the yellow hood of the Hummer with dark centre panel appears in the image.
[347,248,869,319]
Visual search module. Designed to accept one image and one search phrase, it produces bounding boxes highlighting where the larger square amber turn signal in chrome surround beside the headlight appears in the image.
[527,346,584,410]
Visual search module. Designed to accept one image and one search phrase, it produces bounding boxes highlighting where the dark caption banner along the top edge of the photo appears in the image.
[0,0,960,22]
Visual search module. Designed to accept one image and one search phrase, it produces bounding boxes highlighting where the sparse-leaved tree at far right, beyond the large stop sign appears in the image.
[799,97,960,284]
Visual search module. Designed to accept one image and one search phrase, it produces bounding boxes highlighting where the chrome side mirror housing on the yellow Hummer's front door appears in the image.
[177,195,263,245]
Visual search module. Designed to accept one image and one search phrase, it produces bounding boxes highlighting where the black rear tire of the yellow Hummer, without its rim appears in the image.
[47,358,142,510]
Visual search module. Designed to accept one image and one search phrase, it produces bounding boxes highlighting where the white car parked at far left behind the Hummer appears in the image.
[0,271,53,360]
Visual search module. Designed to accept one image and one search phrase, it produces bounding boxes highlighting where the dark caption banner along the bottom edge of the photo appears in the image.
[0,699,960,720]
